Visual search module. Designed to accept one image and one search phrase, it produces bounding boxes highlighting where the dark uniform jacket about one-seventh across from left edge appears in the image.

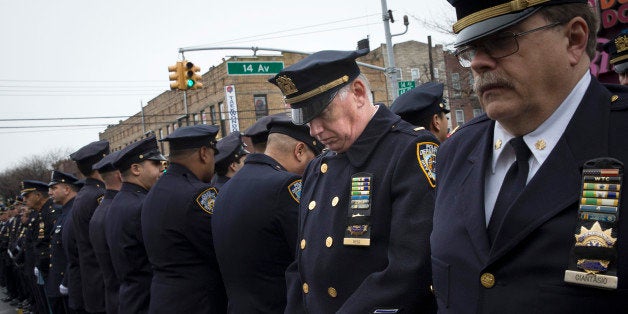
[70,178,105,313]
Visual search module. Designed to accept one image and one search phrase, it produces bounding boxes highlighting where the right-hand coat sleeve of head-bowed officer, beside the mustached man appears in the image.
[338,136,438,313]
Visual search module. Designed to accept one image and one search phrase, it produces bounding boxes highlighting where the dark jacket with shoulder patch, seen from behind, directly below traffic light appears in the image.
[142,163,227,313]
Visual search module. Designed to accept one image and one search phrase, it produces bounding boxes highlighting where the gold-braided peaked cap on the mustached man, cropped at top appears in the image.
[447,0,588,47]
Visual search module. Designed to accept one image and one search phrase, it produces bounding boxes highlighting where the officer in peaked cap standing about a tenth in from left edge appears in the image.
[45,170,78,314]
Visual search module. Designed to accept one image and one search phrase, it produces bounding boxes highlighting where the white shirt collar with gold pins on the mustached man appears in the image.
[491,72,591,172]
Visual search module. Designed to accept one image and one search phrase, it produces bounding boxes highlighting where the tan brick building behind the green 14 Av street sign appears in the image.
[99,41,445,154]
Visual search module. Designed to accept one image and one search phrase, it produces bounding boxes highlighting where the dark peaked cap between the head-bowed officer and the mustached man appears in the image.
[390,82,449,125]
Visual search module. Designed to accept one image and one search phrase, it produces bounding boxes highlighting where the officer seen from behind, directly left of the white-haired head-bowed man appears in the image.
[212,115,323,313]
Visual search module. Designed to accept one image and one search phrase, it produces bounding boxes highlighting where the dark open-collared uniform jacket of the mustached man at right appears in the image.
[431,78,628,313]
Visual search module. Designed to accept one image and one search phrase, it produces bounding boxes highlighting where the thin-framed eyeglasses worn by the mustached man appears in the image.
[454,22,562,68]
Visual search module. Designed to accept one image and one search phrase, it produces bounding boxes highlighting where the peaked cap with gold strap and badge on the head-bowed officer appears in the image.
[268,49,369,125]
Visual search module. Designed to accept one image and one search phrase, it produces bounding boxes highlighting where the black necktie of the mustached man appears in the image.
[488,136,532,244]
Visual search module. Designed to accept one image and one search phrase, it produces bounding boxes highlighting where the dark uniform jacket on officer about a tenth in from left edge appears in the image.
[45,198,74,298]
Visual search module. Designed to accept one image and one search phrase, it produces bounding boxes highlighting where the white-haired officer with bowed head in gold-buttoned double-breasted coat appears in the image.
[270,49,438,313]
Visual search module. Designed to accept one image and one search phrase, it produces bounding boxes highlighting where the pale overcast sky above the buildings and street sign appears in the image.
[0,0,455,171]
